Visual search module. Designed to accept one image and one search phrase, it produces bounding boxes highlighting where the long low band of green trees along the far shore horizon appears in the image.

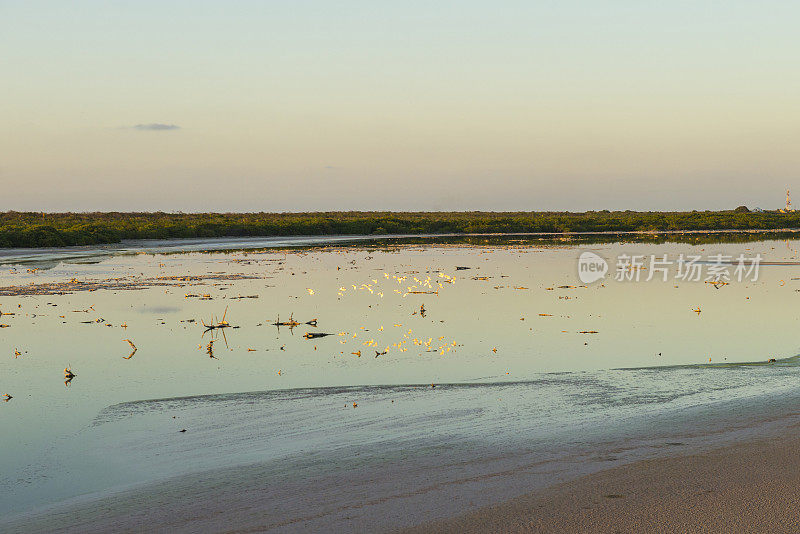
[0,210,800,248]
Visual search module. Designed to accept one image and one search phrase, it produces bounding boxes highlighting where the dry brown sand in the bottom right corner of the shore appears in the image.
[403,427,800,534]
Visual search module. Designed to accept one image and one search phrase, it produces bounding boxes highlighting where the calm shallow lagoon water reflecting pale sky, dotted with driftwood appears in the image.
[0,241,800,524]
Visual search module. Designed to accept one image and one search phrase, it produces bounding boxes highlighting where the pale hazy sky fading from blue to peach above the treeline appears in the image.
[0,0,800,212]
